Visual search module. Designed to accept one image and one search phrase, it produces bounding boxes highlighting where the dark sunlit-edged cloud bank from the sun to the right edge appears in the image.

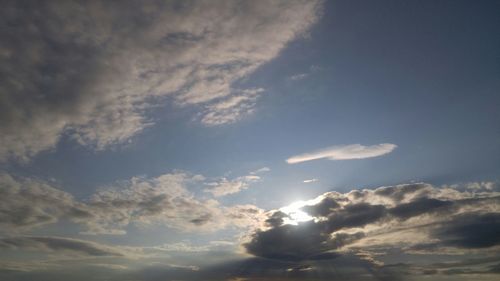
[244,183,500,261]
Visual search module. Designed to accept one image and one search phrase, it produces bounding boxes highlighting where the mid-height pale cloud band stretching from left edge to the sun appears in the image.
[0,172,263,234]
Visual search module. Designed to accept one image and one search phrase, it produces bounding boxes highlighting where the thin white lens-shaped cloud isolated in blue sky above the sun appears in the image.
[286,143,397,164]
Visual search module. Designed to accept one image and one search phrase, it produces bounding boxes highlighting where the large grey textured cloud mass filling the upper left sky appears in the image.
[0,0,321,161]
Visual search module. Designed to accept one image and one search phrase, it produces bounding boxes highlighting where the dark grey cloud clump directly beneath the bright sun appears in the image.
[245,201,385,261]
